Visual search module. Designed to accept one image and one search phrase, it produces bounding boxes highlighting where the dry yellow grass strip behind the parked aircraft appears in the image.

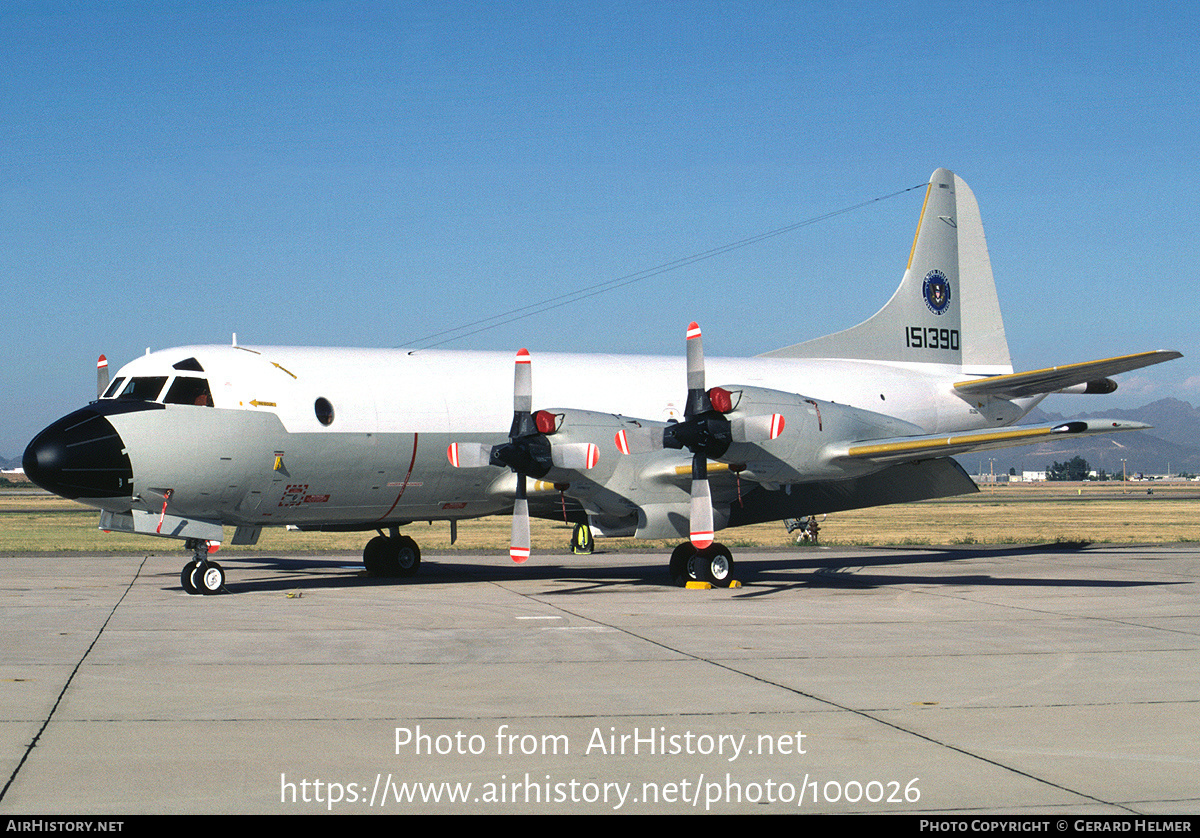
[0,483,1200,553]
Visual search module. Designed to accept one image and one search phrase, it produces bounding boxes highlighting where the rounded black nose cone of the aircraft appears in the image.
[22,407,133,499]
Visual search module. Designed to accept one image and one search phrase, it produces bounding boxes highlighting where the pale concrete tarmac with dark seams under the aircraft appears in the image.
[0,545,1200,818]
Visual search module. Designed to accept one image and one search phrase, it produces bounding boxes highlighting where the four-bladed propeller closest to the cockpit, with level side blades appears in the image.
[446,349,600,563]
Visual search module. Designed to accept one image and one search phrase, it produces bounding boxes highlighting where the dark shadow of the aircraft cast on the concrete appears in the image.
[154,541,1171,597]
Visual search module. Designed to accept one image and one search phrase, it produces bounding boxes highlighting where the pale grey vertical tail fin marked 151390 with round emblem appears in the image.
[764,169,1013,375]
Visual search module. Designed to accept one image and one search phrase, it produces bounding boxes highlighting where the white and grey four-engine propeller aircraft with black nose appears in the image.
[24,169,1180,593]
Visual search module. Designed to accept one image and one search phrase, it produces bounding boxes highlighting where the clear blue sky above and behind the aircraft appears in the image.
[0,0,1200,456]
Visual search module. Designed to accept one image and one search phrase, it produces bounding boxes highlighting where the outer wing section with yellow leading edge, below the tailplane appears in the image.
[832,419,1151,463]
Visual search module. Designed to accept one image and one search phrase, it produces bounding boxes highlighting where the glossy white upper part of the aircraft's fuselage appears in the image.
[108,338,1025,433]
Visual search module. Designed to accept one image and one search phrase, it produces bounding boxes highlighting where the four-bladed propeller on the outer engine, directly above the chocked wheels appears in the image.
[617,322,784,550]
